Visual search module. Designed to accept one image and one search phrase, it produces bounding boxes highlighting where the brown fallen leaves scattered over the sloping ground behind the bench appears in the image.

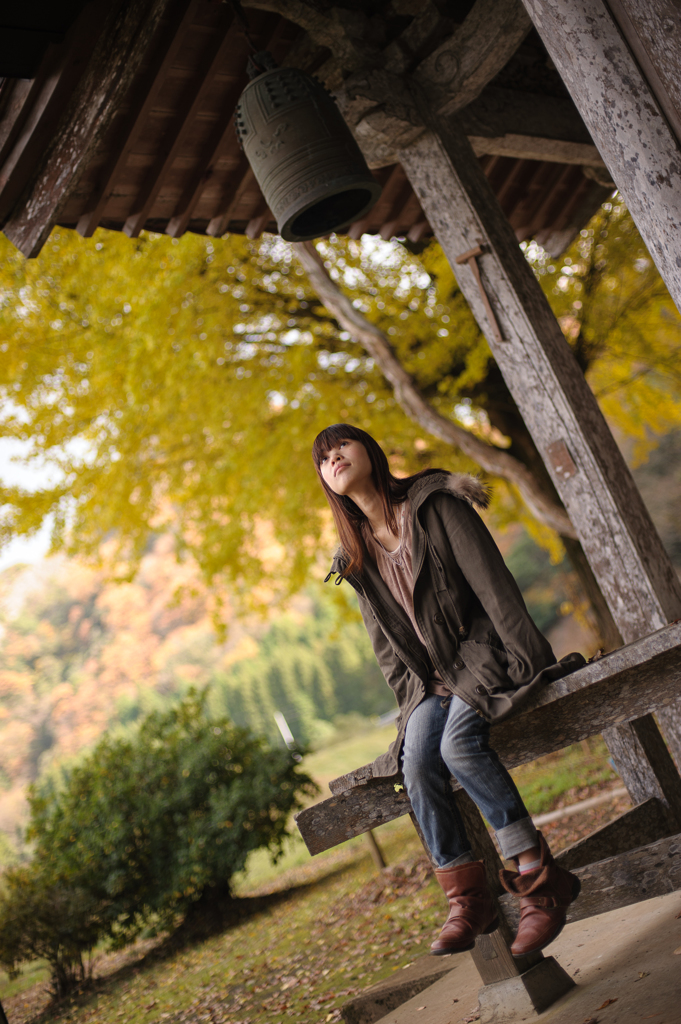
[3,774,647,1024]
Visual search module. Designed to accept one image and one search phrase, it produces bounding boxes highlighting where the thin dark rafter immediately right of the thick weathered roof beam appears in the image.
[76,0,199,239]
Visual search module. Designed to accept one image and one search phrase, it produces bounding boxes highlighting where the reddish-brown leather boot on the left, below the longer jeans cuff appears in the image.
[430,860,499,956]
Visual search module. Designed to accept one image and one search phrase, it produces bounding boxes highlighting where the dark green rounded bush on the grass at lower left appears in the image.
[0,692,317,991]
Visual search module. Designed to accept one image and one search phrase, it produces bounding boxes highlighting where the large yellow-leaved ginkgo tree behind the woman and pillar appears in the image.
[0,197,681,632]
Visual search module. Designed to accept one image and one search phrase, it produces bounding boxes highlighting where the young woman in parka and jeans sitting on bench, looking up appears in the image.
[312,423,585,956]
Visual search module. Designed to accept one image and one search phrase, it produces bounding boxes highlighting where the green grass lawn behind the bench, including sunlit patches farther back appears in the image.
[0,726,616,1024]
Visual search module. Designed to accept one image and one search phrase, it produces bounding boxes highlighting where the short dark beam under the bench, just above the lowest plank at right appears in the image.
[556,797,678,871]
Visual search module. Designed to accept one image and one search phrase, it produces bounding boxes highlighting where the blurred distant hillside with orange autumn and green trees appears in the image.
[0,538,394,862]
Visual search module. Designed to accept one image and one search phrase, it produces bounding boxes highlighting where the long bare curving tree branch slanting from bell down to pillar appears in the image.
[293,242,577,539]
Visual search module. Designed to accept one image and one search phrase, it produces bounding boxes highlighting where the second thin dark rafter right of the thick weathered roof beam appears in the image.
[123,5,235,239]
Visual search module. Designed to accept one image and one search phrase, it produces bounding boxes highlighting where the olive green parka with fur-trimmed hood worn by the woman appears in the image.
[327,472,585,776]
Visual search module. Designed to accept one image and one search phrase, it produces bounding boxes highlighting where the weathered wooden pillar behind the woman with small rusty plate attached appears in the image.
[400,117,681,823]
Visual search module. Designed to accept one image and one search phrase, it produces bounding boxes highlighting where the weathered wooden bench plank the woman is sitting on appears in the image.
[296,623,681,854]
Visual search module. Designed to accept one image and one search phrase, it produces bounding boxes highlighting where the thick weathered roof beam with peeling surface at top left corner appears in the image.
[3,0,176,256]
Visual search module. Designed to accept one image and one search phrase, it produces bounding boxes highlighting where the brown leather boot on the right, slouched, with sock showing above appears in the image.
[499,831,582,956]
